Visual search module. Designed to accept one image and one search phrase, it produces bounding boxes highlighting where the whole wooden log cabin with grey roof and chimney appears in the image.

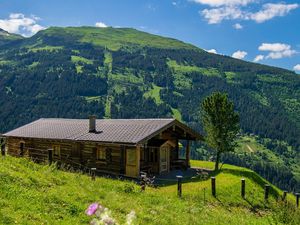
[3,116,202,177]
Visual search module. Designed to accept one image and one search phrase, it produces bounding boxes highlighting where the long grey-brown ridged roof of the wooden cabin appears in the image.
[4,118,200,144]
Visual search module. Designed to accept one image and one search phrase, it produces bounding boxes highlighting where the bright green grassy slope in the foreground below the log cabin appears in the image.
[0,156,300,225]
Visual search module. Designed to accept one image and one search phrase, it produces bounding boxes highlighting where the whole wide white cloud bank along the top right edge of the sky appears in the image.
[195,0,299,24]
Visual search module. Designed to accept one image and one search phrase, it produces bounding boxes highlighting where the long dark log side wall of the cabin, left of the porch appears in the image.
[7,137,126,175]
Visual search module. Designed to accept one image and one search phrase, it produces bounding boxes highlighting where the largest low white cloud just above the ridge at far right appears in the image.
[258,43,297,59]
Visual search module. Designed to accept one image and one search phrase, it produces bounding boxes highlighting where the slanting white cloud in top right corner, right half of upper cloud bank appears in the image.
[250,3,299,23]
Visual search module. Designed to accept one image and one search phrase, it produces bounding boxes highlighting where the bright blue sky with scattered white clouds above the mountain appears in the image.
[0,0,300,72]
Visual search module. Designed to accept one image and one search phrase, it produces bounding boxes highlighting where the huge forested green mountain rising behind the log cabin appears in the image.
[0,27,300,190]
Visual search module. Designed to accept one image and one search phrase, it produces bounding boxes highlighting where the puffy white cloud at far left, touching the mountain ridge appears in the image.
[0,13,45,36]
